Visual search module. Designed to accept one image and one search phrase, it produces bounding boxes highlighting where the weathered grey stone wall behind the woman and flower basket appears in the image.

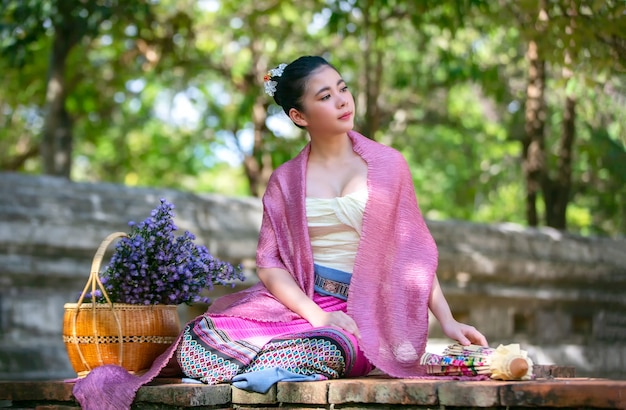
[0,173,626,379]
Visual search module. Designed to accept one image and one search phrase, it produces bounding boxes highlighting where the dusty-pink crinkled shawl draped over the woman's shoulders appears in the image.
[208,131,438,377]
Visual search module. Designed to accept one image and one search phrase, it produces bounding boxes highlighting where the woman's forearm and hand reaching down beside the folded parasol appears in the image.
[428,275,488,346]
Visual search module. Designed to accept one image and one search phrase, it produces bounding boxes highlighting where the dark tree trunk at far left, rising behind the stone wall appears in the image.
[41,23,76,179]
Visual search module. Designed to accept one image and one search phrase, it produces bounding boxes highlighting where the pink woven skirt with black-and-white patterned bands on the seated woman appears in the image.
[176,294,372,384]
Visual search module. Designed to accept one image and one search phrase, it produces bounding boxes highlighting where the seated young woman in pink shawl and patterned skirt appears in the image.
[74,56,487,409]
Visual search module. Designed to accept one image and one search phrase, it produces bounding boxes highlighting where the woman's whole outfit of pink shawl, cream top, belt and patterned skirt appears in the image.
[73,131,438,410]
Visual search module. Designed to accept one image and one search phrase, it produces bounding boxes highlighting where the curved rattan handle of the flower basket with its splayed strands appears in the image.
[72,232,128,370]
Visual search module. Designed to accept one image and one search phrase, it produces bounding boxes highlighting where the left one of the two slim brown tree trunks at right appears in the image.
[522,41,546,226]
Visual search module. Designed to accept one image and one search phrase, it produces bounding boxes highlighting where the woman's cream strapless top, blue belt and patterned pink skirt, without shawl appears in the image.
[177,189,372,392]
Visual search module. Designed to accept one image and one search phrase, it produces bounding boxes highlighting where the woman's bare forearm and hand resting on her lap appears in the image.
[258,268,360,337]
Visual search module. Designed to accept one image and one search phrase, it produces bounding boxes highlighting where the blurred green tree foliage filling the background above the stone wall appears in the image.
[0,0,626,234]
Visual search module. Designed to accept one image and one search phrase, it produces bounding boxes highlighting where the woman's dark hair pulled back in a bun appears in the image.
[272,56,336,115]
